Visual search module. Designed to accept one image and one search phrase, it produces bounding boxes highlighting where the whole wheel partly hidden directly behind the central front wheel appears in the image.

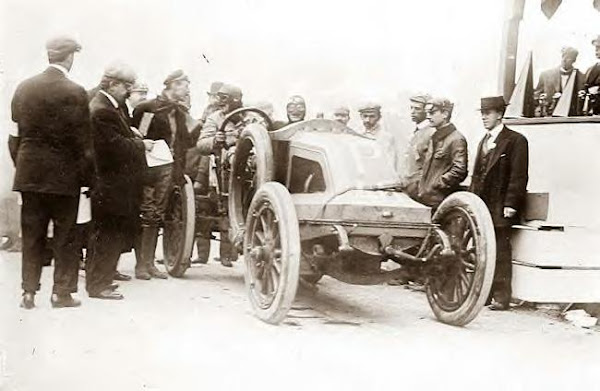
[228,124,275,250]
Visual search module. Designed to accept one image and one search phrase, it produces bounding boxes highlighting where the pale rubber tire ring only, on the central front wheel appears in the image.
[244,182,301,324]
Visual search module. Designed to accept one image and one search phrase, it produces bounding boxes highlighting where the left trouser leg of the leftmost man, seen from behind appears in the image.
[21,192,50,293]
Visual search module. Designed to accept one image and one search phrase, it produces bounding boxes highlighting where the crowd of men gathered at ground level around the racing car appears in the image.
[12,37,528,309]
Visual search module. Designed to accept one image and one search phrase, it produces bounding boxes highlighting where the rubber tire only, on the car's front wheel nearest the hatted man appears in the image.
[426,192,496,326]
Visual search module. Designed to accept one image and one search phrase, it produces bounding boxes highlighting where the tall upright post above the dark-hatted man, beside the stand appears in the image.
[498,0,525,102]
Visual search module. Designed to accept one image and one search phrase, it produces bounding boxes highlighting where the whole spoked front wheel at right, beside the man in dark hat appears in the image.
[427,192,496,326]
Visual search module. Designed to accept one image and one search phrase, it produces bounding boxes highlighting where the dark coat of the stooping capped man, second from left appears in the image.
[90,93,146,218]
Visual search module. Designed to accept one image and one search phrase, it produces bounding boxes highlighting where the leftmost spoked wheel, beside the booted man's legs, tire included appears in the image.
[163,176,196,277]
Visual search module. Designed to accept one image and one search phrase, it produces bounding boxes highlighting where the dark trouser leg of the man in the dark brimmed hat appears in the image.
[492,227,512,304]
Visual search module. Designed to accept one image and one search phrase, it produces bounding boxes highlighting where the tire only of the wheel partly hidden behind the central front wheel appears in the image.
[228,124,275,248]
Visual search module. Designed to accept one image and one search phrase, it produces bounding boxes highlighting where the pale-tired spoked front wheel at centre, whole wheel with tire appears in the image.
[243,182,300,324]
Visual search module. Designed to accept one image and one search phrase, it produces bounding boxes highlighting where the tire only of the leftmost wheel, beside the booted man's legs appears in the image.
[163,175,196,278]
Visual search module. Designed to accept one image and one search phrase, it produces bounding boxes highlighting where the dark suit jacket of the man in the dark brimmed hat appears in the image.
[469,126,529,227]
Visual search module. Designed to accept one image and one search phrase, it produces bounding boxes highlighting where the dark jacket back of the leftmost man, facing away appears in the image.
[11,67,93,196]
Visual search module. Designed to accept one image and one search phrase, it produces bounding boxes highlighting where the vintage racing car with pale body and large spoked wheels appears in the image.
[165,108,496,325]
